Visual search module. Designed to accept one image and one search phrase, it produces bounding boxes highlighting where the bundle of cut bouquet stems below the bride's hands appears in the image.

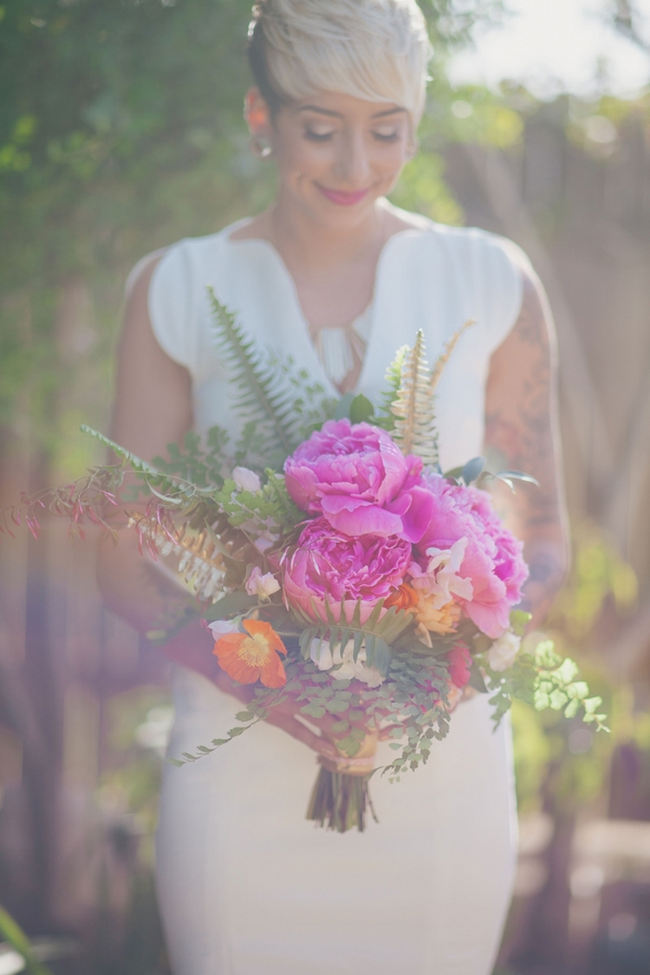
[307,733,379,833]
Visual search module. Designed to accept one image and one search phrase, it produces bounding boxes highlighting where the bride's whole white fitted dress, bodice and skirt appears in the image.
[149,212,522,975]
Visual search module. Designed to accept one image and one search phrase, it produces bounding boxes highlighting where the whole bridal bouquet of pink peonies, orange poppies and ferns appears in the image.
[5,297,604,831]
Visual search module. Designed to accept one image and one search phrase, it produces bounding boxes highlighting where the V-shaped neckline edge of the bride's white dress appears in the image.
[224,208,432,397]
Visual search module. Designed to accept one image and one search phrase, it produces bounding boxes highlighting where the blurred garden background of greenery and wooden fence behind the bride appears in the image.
[0,0,650,975]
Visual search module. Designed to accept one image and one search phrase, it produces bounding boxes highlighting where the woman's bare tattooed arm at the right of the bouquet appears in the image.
[485,260,568,626]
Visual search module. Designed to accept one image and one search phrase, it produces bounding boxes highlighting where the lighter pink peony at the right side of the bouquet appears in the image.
[416,474,528,639]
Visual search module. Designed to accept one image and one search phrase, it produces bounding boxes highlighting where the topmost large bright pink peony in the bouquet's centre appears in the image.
[284,419,431,541]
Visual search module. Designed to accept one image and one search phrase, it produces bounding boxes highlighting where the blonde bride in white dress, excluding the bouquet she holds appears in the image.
[99,0,565,975]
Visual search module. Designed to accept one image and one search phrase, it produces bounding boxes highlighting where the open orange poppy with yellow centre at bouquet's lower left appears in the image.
[212,620,287,687]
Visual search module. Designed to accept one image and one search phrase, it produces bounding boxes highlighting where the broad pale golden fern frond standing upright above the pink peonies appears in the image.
[391,330,438,464]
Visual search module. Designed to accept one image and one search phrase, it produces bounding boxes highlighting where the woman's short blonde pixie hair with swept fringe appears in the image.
[248,0,431,125]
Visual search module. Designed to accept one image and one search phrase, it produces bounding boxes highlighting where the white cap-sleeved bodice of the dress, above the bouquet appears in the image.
[149,206,522,468]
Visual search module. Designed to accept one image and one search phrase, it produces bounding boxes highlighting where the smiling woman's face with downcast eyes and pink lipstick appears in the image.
[262,92,413,228]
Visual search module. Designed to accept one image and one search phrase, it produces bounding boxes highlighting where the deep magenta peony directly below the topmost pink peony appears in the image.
[281,517,411,622]
